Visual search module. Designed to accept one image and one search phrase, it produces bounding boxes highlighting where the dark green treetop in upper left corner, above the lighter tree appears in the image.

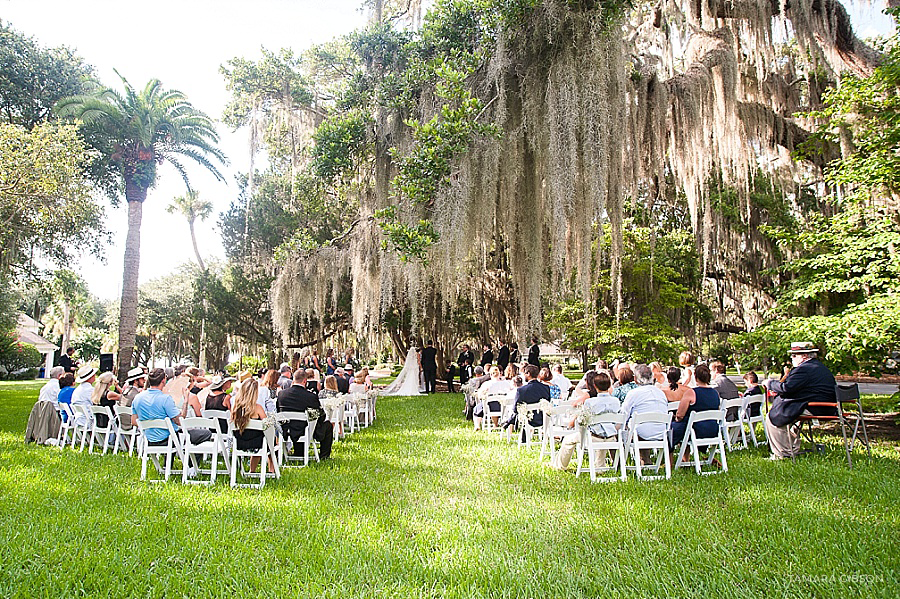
[0,21,93,129]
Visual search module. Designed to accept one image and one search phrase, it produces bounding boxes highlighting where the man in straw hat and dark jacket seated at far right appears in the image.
[765,341,835,459]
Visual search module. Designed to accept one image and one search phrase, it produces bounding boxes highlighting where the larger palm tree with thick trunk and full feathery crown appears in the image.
[56,71,226,378]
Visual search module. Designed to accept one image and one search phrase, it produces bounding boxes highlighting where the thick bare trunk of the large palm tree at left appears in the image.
[119,185,147,380]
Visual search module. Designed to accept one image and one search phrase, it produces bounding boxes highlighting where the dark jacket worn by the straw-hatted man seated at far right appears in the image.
[769,358,835,426]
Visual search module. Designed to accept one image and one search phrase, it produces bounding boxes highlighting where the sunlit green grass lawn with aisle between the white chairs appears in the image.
[0,383,900,598]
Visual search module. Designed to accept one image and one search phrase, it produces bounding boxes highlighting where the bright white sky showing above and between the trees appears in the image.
[0,0,891,300]
